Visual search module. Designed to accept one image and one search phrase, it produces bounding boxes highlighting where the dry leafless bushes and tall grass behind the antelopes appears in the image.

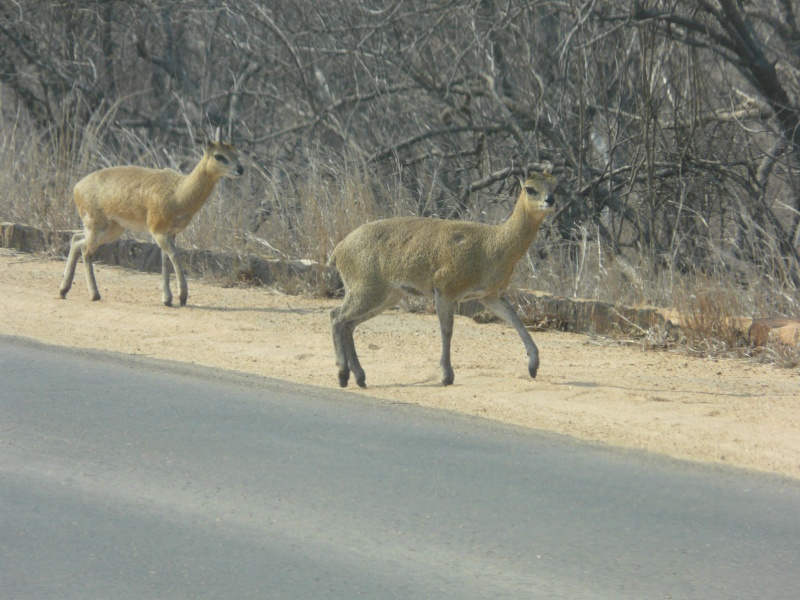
[0,0,800,366]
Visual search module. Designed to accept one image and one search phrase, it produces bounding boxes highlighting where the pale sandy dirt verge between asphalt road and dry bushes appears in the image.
[0,251,800,478]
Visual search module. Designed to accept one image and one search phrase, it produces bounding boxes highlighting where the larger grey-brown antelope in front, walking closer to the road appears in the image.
[328,171,557,387]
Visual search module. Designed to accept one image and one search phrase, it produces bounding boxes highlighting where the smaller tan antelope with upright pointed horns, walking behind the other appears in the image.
[60,134,244,306]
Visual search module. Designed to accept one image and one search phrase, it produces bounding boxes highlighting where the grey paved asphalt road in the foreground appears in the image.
[0,337,800,600]
